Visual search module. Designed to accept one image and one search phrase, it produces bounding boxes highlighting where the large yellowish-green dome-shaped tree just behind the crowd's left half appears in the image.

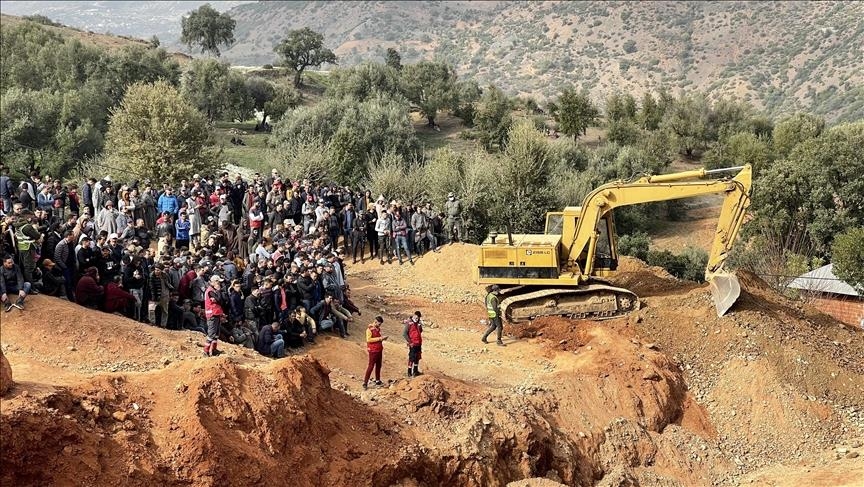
[105,81,218,181]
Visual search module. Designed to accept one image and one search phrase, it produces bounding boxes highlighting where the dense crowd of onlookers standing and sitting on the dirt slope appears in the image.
[0,167,462,370]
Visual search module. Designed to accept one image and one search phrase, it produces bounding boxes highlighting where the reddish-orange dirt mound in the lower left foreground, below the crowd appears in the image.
[0,357,416,486]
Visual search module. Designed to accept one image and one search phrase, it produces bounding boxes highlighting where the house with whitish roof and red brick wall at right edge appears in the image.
[787,264,864,327]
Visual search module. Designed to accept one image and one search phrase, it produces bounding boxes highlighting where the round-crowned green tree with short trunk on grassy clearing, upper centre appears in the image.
[401,61,456,127]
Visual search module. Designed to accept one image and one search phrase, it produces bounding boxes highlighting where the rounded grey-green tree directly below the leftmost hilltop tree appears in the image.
[183,59,255,123]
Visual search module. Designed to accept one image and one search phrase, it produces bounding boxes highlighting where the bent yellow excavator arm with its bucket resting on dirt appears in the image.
[564,164,752,316]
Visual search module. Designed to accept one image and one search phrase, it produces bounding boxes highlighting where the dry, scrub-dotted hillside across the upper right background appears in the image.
[224,2,864,121]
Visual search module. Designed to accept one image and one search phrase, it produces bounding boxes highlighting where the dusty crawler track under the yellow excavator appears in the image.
[501,284,639,323]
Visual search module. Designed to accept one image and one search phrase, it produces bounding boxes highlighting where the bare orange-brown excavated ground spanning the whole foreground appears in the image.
[0,246,864,486]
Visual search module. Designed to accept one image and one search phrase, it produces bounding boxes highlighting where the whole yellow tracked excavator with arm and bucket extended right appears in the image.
[474,164,752,323]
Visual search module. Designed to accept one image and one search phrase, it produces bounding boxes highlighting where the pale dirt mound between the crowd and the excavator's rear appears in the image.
[351,243,484,304]
